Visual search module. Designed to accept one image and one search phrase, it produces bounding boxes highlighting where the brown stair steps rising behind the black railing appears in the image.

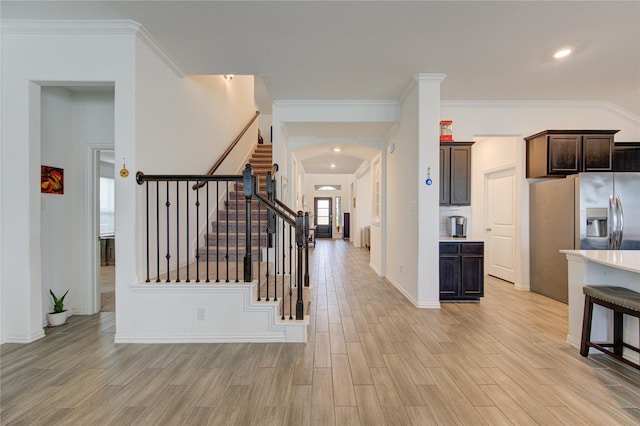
[198,144,273,262]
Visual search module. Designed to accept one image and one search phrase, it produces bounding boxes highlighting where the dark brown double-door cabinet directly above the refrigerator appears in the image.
[525,130,618,178]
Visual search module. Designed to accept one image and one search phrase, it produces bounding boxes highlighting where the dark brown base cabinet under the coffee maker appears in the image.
[440,242,484,301]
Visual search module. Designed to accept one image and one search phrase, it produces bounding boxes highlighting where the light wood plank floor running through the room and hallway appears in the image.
[0,240,640,425]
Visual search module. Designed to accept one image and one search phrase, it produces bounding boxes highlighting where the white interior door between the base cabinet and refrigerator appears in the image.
[485,167,516,283]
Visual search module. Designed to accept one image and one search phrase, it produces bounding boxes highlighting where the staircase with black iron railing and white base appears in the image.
[134,144,310,343]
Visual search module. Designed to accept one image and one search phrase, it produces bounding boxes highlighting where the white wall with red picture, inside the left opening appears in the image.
[41,87,114,320]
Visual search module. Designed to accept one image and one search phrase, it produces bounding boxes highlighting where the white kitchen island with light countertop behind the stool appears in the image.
[560,250,640,363]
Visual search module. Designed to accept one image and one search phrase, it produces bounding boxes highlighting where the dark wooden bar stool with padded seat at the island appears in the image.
[580,285,640,370]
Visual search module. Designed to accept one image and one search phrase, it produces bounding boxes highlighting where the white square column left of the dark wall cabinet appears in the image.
[415,74,446,308]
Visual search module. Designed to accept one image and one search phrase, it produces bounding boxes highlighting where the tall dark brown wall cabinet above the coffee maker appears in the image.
[440,142,473,206]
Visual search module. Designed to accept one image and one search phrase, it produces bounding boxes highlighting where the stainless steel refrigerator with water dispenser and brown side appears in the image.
[529,173,640,303]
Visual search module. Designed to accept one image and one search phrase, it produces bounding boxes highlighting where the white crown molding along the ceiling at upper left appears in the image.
[0,19,185,77]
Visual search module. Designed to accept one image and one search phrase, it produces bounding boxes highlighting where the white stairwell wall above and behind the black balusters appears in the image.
[129,35,258,280]
